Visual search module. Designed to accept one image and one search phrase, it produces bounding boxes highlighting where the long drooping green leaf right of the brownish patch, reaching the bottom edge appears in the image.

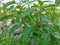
[20,27,32,45]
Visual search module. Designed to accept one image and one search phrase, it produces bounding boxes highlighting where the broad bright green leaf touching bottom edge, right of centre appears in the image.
[39,33,50,45]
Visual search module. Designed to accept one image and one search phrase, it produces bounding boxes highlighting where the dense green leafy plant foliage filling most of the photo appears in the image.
[0,0,60,45]
